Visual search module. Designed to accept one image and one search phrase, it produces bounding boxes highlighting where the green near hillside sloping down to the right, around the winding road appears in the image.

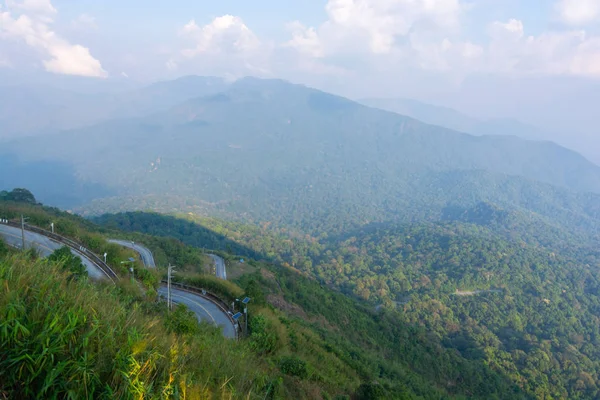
[0,190,530,400]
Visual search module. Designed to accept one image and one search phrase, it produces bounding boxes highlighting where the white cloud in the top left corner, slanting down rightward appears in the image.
[0,0,107,77]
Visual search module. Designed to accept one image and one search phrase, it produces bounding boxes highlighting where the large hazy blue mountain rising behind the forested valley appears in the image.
[0,77,600,230]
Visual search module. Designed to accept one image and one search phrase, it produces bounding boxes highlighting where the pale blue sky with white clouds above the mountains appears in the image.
[0,0,600,155]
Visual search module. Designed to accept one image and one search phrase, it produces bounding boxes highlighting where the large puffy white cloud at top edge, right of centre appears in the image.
[284,0,483,76]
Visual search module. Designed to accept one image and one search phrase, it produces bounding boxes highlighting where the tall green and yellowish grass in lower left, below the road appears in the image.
[0,255,273,399]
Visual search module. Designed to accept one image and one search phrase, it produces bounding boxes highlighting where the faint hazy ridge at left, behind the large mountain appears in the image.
[0,76,226,140]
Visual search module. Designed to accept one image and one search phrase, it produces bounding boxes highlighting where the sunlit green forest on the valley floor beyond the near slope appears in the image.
[97,208,600,399]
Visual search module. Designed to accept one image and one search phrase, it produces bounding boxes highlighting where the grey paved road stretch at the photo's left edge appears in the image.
[0,224,106,279]
